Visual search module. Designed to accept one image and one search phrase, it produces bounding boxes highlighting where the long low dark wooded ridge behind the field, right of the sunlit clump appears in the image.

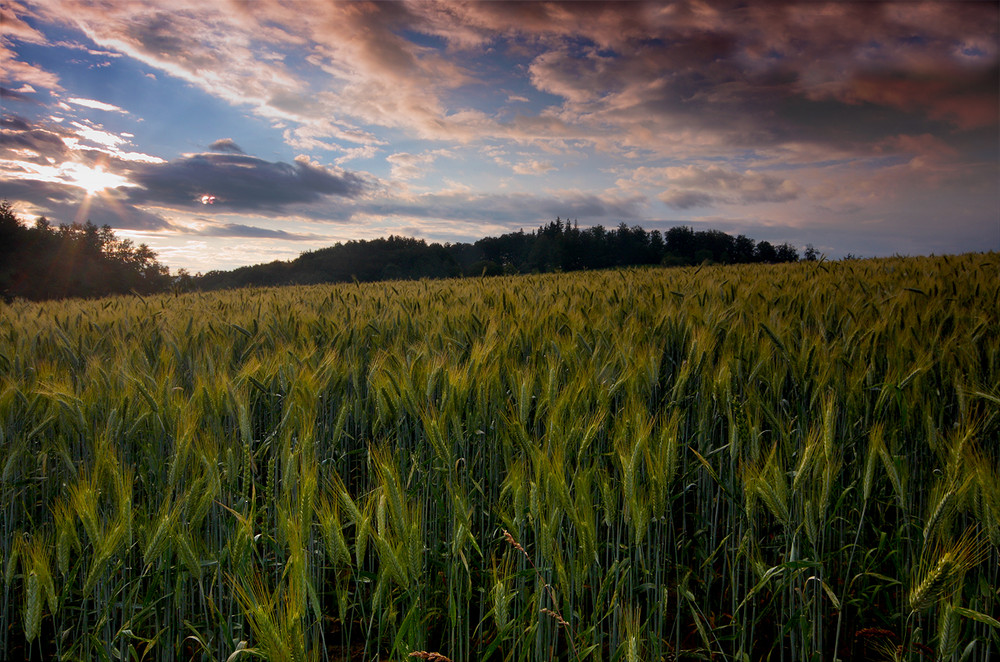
[197,218,818,290]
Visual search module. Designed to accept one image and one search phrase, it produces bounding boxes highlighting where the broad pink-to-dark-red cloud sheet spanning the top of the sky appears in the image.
[21,0,1000,161]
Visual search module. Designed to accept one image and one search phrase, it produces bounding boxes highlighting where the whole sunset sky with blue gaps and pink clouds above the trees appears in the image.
[0,0,1000,273]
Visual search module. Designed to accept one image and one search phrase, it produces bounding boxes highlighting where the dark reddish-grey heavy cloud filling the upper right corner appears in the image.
[529,3,997,157]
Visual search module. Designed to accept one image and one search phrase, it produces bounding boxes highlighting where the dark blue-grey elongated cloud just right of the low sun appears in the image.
[129,153,370,211]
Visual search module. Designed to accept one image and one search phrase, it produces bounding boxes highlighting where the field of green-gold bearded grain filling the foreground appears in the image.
[0,254,1000,662]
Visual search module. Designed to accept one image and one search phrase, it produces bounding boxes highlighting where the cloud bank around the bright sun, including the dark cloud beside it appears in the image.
[0,115,374,233]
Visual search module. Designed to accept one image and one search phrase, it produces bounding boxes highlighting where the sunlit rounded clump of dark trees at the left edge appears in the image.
[0,200,174,301]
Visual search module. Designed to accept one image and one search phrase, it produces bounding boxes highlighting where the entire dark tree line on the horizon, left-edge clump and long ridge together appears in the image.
[0,201,817,300]
